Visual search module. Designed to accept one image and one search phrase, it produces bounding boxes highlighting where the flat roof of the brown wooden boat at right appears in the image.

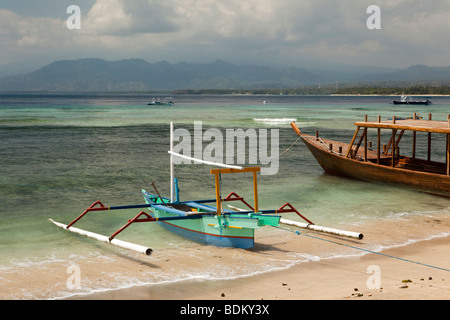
[355,119,450,134]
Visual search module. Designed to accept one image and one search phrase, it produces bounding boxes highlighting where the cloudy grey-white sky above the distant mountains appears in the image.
[0,0,450,73]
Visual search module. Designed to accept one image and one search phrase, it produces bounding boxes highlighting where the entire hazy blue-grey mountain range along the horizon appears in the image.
[0,58,450,92]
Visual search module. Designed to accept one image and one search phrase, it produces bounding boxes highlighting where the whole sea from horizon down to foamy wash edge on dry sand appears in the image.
[0,93,450,299]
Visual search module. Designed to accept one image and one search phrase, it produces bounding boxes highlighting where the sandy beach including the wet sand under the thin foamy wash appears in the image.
[0,214,450,301]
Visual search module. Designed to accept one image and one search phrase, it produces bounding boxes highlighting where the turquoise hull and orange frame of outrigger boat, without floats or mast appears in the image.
[142,167,281,249]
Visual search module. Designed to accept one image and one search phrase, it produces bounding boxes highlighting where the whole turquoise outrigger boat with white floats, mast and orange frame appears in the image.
[50,124,363,255]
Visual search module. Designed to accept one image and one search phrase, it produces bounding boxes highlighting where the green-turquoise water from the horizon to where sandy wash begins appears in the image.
[0,94,450,298]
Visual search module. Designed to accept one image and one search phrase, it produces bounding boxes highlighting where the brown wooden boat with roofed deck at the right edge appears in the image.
[291,114,450,196]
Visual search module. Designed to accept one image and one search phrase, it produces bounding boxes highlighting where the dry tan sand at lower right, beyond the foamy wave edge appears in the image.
[72,237,450,301]
